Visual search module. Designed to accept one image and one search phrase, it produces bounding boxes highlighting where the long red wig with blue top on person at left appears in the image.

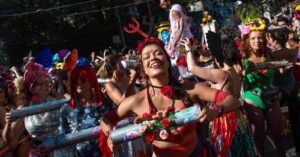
[70,58,104,107]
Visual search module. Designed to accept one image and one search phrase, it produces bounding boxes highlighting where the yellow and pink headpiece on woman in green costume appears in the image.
[240,17,267,36]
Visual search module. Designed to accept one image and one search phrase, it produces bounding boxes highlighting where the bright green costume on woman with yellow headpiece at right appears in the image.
[244,58,274,111]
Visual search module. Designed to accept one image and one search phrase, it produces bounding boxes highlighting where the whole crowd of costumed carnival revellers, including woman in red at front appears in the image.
[0,0,300,157]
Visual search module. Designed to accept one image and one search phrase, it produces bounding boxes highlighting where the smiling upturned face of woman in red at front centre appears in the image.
[141,44,170,78]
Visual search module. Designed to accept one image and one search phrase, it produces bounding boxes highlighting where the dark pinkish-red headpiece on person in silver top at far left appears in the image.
[24,62,49,92]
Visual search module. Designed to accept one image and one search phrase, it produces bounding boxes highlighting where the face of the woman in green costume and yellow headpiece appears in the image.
[249,31,264,51]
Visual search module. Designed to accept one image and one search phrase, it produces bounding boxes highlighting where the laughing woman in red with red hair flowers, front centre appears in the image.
[100,38,240,157]
